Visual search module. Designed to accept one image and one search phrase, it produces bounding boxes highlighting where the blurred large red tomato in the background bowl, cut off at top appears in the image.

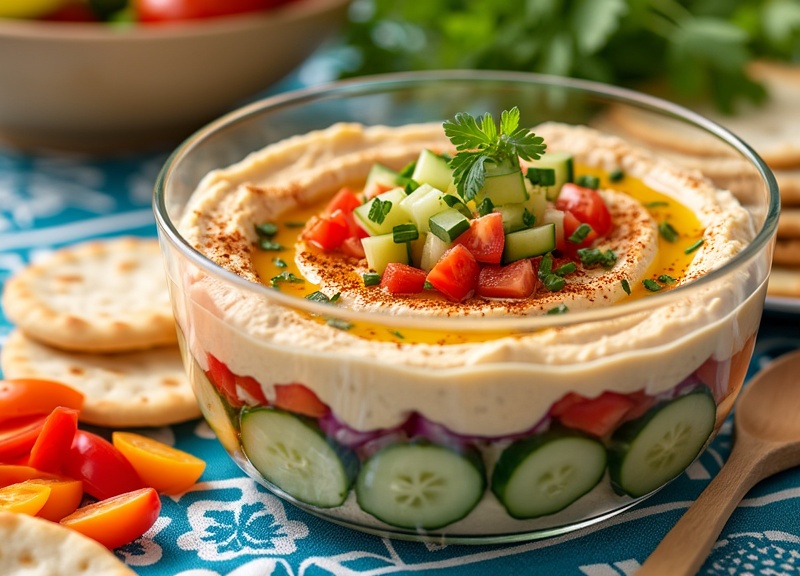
[132,0,286,22]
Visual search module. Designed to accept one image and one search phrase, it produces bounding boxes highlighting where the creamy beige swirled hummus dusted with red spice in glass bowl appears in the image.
[177,124,766,436]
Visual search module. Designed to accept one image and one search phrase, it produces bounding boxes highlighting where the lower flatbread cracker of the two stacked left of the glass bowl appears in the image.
[0,330,200,428]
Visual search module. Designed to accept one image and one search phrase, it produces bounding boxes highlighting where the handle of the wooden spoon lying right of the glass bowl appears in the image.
[636,448,762,576]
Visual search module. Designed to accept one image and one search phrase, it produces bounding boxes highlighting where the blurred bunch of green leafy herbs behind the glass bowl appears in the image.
[340,0,800,112]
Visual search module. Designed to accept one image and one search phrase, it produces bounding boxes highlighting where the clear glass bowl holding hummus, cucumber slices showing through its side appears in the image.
[155,71,779,543]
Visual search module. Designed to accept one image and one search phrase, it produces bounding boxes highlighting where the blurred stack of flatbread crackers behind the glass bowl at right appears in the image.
[597,61,800,298]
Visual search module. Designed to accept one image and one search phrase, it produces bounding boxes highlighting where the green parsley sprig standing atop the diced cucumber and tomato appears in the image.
[444,106,546,202]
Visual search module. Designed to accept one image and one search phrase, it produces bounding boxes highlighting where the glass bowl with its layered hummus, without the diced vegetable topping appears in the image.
[155,71,779,543]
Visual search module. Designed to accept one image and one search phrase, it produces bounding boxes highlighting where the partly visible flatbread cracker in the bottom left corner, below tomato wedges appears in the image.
[0,511,136,576]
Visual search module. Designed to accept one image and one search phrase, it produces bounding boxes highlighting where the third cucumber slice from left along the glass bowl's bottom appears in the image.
[492,432,606,519]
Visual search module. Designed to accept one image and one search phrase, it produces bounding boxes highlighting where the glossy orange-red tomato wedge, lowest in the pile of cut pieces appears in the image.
[60,488,161,550]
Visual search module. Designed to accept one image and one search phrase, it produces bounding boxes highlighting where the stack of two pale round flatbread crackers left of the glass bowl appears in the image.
[0,237,200,428]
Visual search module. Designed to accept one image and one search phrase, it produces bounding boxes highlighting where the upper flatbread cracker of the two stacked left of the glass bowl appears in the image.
[3,237,177,352]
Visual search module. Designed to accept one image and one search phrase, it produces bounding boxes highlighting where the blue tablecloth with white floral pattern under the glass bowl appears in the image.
[0,60,800,576]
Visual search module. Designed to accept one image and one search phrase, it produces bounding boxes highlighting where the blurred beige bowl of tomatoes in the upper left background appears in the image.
[0,0,349,152]
